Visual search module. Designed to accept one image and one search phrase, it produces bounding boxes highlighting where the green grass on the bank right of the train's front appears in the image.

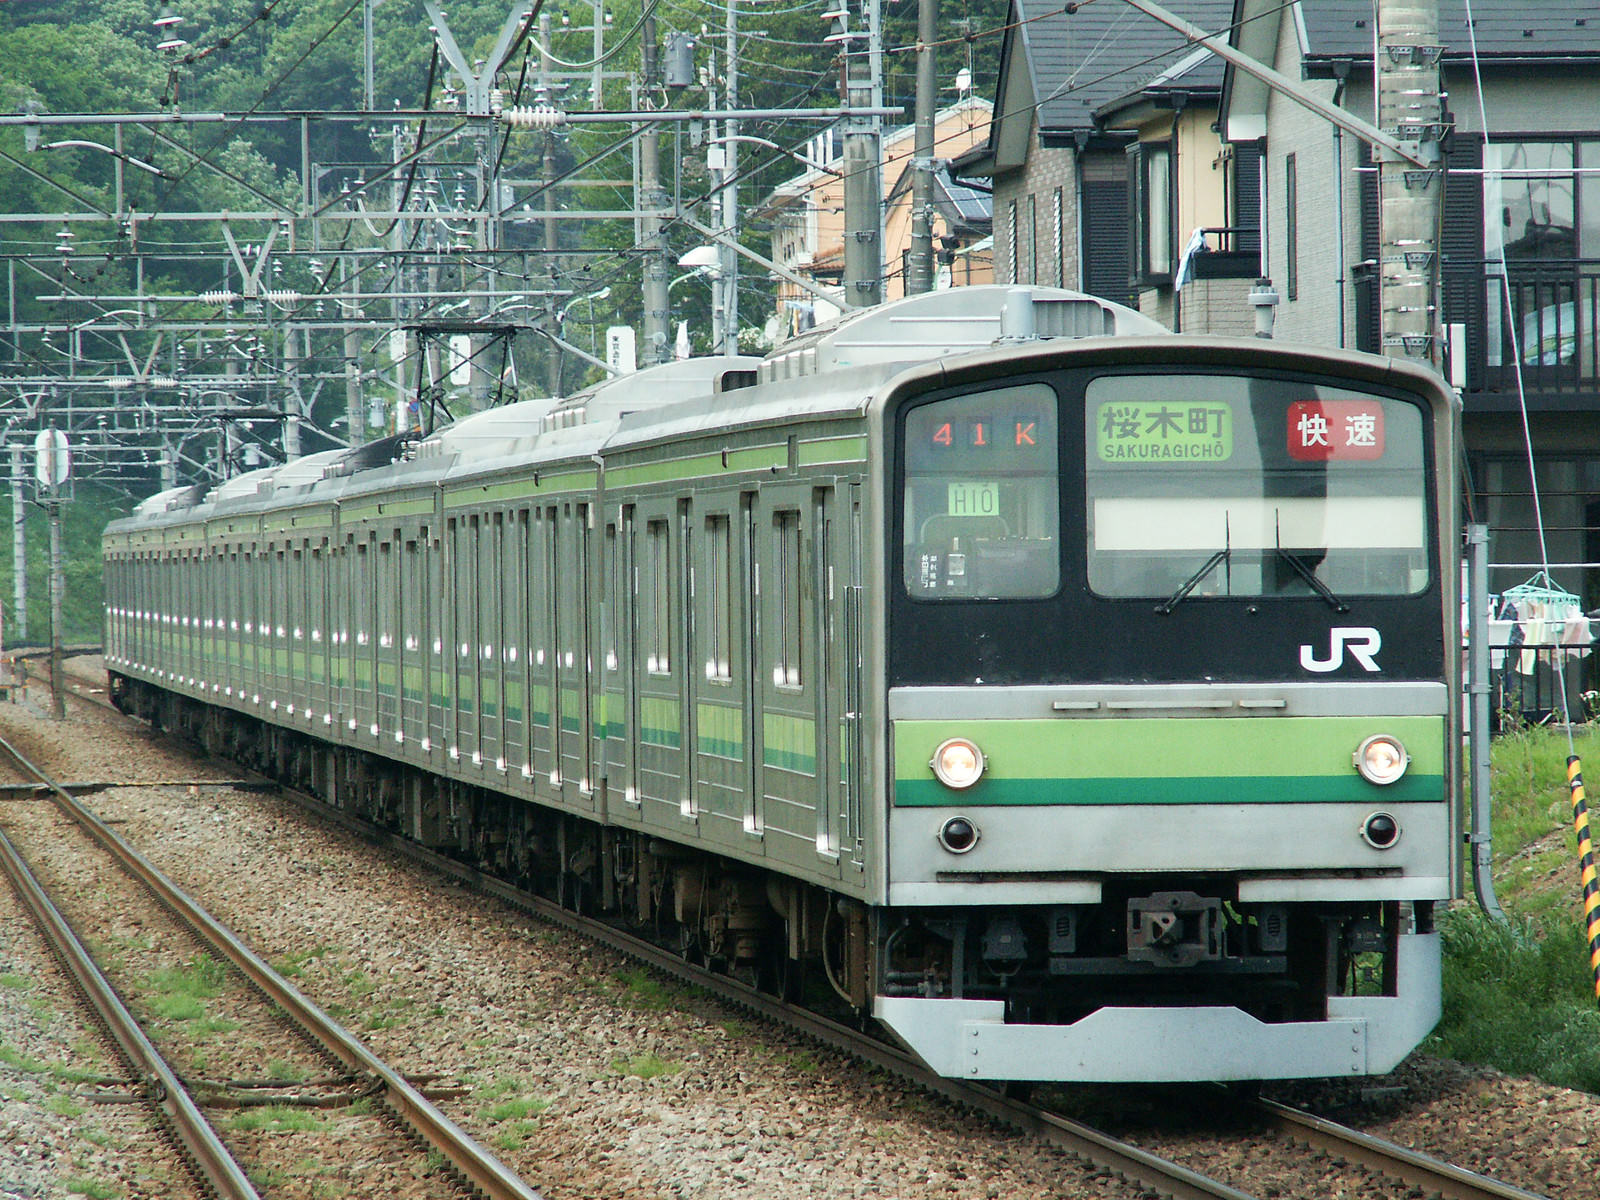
[1427,730,1600,1093]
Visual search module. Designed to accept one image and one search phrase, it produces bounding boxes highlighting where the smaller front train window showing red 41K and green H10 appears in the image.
[902,384,1061,600]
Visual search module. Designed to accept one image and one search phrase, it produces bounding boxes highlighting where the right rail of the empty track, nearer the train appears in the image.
[0,739,541,1200]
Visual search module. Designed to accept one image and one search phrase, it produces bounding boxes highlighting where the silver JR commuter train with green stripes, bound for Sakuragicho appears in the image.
[104,286,1459,1082]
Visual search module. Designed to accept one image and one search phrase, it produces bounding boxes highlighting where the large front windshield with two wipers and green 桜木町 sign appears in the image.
[1085,374,1429,602]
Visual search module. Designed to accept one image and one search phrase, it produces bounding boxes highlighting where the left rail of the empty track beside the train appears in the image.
[0,793,261,1200]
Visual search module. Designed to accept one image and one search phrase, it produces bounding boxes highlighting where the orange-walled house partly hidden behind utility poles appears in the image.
[757,96,994,333]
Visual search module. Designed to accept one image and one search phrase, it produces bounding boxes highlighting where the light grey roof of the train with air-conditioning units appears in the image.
[118,285,1465,525]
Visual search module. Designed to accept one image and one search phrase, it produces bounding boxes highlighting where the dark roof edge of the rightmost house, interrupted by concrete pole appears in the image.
[1305,0,1600,61]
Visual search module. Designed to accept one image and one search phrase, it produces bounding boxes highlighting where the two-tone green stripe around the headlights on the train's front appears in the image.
[894,717,1445,806]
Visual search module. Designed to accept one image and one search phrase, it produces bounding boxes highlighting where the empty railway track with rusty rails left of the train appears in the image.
[0,723,538,1200]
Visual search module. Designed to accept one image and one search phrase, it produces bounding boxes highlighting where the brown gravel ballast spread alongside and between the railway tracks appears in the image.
[0,672,1600,1200]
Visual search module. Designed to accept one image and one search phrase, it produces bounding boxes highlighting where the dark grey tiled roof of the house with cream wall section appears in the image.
[1013,0,1234,130]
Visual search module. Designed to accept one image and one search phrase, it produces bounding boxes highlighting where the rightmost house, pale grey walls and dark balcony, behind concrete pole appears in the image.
[1221,0,1600,608]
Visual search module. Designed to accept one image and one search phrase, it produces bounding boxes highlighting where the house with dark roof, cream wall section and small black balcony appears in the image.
[955,0,1259,333]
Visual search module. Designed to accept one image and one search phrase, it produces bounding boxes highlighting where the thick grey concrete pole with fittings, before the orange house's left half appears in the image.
[824,0,883,307]
